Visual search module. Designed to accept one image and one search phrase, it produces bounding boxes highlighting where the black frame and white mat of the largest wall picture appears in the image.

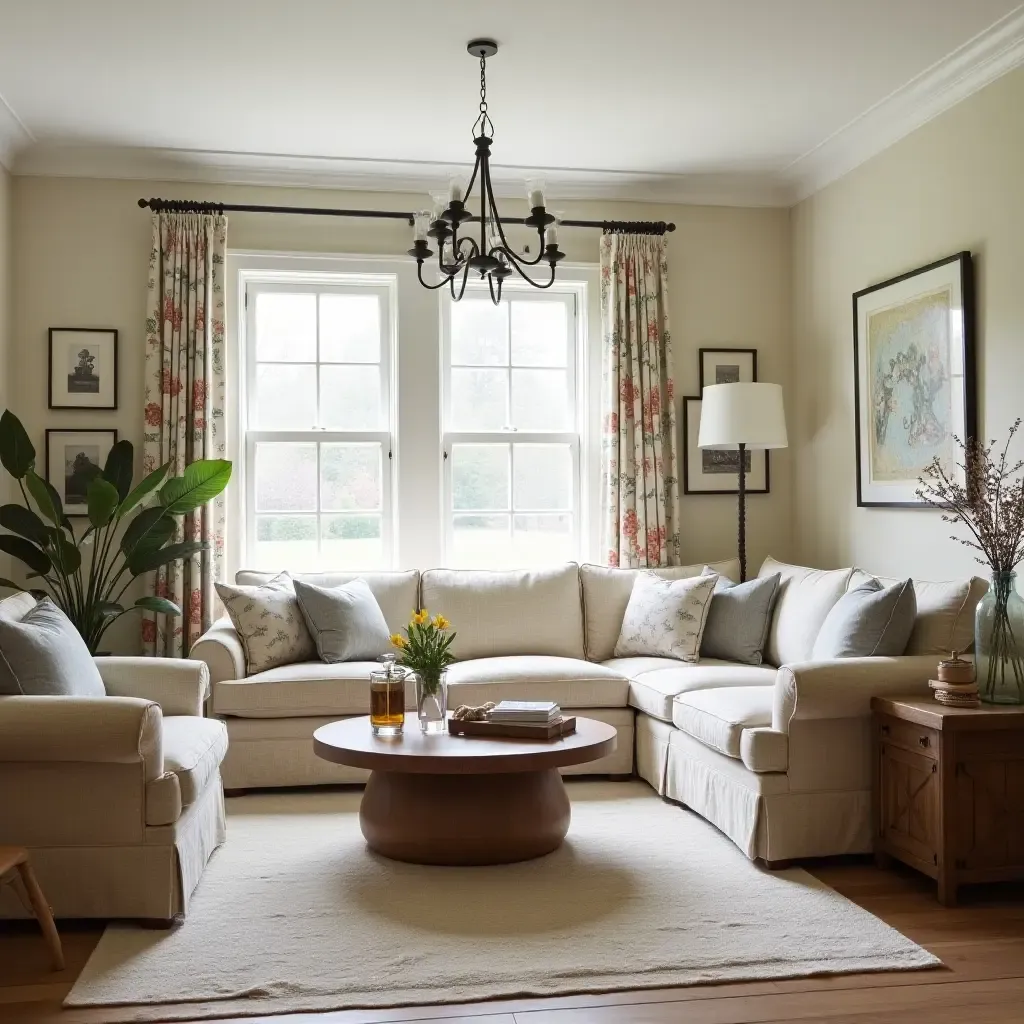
[853,250,978,509]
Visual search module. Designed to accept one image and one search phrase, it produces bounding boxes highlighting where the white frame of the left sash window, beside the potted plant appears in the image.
[239,269,397,571]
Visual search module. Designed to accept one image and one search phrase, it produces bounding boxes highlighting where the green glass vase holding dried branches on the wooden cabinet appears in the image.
[974,572,1024,703]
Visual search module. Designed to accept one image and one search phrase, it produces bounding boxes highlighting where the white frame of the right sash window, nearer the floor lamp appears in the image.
[441,280,590,565]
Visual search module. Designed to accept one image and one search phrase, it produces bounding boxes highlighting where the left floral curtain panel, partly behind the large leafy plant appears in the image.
[142,213,227,657]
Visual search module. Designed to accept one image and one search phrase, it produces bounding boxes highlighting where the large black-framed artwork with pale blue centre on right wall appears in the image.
[853,252,978,508]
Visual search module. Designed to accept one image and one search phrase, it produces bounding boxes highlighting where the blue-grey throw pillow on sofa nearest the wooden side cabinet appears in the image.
[812,580,918,662]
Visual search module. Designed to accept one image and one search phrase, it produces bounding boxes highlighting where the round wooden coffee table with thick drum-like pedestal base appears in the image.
[313,717,615,864]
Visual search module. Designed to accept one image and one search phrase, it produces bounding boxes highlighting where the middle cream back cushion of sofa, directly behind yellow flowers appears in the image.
[421,562,584,662]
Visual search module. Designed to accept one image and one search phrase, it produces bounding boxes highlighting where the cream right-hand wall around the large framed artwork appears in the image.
[790,71,1024,579]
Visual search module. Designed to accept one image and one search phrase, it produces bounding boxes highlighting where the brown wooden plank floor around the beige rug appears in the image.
[0,862,1024,1024]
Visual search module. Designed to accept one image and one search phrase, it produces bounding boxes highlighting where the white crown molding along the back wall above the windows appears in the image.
[13,143,790,207]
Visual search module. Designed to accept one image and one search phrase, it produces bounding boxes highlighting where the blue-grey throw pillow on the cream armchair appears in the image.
[0,597,106,697]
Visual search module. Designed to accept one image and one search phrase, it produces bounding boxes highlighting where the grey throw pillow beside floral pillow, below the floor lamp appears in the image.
[700,565,782,665]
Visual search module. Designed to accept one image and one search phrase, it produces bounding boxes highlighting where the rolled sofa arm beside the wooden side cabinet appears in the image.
[772,654,937,732]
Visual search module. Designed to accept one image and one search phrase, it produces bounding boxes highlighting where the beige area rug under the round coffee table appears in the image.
[66,781,940,1022]
